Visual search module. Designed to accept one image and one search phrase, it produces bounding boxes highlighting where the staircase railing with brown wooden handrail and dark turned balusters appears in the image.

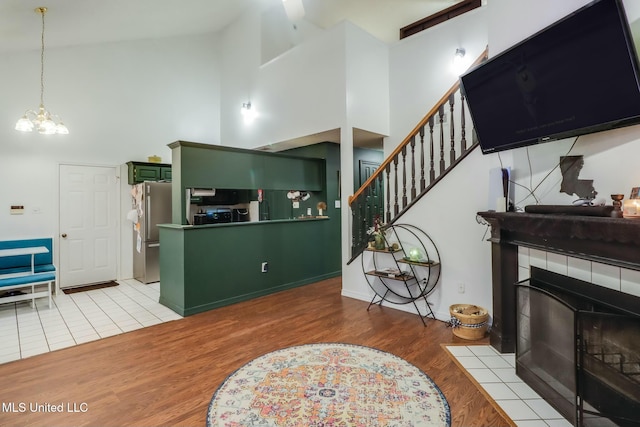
[349,49,488,263]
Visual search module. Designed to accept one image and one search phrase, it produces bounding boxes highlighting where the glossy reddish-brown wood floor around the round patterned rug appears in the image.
[0,278,513,427]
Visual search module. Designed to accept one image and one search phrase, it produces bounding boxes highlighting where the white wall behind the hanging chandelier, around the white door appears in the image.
[0,35,220,278]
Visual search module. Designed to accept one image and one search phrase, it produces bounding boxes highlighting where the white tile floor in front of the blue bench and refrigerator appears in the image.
[0,280,182,363]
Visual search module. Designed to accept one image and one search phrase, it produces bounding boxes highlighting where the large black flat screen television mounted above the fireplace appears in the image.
[460,0,640,154]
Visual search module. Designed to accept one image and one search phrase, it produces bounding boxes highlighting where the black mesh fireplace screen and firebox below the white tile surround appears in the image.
[516,267,640,427]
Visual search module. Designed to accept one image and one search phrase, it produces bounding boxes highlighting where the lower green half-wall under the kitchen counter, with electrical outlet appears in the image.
[160,219,340,316]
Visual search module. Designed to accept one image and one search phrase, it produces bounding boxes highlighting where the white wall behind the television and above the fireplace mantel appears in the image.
[489,0,640,207]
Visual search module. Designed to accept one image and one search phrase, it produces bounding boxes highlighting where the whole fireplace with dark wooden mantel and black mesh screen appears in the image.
[478,212,640,427]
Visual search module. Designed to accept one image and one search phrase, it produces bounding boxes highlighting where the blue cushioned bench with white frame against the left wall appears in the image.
[0,238,56,308]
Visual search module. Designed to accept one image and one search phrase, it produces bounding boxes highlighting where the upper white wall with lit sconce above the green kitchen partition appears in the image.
[221,15,389,148]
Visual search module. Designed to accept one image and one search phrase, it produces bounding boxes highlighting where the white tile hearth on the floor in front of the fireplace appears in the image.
[447,345,572,427]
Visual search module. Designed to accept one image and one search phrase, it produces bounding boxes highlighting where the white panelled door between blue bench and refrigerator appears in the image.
[58,165,118,288]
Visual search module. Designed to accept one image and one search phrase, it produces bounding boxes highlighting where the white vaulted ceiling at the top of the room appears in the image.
[0,0,459,52]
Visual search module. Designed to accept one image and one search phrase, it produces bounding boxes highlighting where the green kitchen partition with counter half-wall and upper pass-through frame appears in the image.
[158,141,341,316]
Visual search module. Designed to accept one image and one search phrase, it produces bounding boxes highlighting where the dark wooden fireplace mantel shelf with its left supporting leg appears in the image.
[478,212,640,353]
